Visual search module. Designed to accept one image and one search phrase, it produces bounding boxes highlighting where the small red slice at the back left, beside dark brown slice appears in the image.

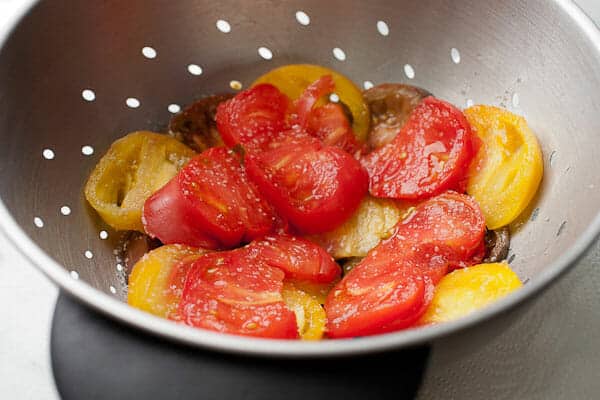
[215,83,290,150]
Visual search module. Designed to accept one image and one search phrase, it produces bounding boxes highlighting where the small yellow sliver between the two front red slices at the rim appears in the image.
[282,282,327,340]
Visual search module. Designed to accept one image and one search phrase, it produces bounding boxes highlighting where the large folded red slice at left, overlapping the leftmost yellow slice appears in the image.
[143,147,275,249]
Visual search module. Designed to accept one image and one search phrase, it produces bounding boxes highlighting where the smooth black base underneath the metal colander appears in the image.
[51,294,429,400]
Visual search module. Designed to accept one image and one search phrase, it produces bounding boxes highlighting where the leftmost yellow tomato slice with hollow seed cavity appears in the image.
[84,131,195,232]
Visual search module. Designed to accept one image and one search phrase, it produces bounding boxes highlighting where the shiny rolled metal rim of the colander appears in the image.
[0,0,600,358]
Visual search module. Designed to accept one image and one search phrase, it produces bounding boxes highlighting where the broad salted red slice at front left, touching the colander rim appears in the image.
[179,250,298,339]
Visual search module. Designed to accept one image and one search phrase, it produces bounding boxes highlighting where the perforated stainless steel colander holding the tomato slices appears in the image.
[0,0,600,356]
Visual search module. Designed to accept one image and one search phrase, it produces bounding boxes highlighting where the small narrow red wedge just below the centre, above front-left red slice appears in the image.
[247,235,342,283]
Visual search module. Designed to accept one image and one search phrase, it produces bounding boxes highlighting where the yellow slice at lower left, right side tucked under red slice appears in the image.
[127,244,206,318]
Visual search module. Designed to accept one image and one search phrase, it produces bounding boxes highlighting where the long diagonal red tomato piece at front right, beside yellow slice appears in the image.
[325,192,485,337]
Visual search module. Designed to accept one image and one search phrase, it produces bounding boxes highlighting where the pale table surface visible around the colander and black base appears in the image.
[0,0,600,400]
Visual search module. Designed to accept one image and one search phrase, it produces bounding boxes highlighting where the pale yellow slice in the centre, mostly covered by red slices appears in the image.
[310,196,410,259]
